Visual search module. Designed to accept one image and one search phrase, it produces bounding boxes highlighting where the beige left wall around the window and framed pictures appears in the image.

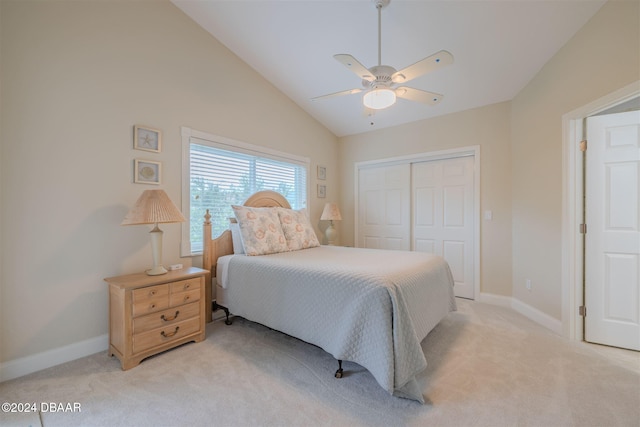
[0,0,338,362]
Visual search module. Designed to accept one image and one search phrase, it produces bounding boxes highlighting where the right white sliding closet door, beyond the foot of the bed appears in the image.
[411,157,474,299]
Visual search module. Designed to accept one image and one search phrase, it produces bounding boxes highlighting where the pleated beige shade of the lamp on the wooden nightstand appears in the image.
[120,190,186,225]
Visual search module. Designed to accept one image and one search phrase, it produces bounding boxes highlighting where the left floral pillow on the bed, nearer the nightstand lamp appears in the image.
[232,206,289,255]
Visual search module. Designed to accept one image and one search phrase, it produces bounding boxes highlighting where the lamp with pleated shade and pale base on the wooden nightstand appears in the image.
[120,190,186,276]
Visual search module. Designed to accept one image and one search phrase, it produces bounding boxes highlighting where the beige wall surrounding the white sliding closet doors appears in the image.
[339,102,511,296]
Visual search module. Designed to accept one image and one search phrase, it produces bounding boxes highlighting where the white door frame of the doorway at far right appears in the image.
[562,80,640,341]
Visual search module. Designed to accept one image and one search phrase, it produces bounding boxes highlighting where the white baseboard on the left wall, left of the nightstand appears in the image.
[0,334,109,382]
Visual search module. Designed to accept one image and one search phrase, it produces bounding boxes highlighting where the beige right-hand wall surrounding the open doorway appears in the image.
[511,0,640,319]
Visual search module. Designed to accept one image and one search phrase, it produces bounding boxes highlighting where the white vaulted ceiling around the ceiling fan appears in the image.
[172,0,606,136]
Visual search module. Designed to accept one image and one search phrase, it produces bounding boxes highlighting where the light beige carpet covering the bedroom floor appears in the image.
[0,300,640,427]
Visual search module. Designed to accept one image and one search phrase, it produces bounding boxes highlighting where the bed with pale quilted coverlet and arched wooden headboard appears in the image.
[203,191,456,403]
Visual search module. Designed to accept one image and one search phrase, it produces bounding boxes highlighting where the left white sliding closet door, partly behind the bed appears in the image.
[357,164,411,250]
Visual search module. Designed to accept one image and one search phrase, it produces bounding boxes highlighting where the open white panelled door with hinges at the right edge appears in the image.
[585,111,640,350]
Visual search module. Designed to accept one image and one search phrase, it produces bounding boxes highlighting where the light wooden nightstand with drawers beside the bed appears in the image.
[104,267,207,370]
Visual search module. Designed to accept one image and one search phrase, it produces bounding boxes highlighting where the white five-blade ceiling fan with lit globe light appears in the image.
[311,0,453,110]
